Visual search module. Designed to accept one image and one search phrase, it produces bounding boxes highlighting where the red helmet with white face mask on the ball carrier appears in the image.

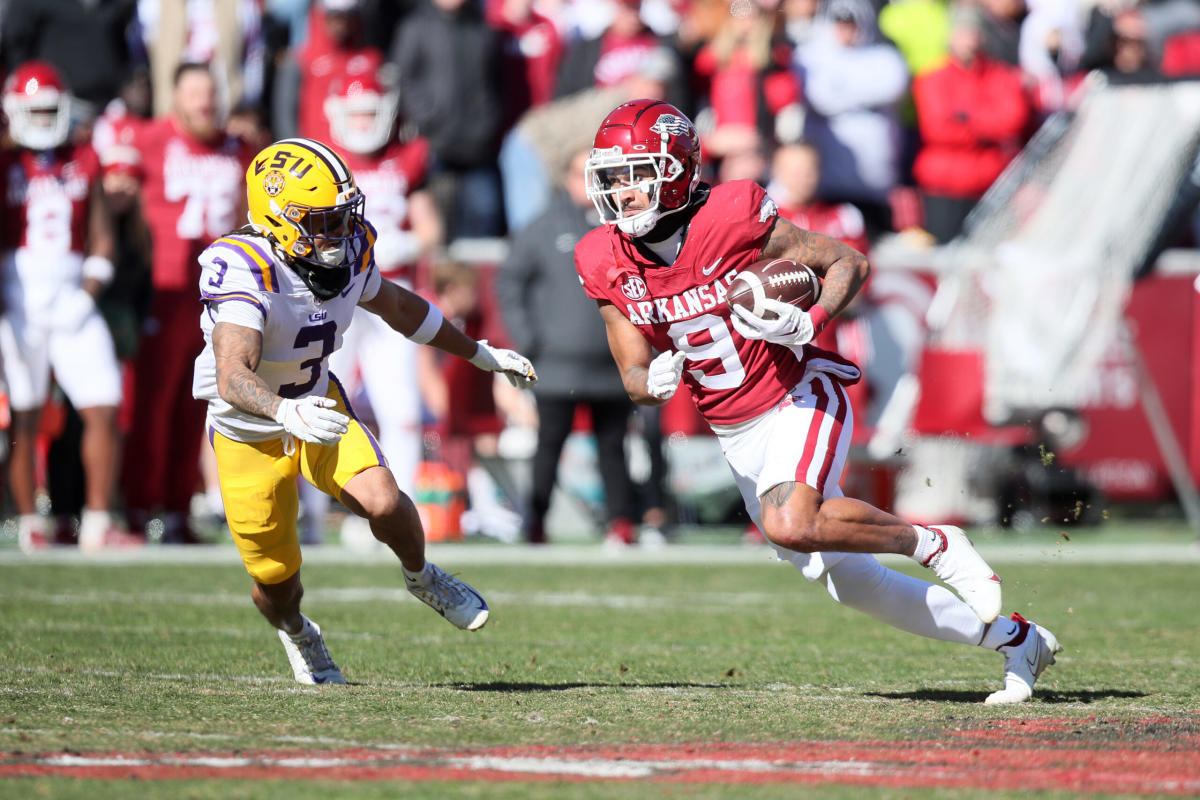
[586,100,700,236]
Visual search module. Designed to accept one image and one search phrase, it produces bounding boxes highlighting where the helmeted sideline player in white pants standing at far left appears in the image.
[0,61,126,551]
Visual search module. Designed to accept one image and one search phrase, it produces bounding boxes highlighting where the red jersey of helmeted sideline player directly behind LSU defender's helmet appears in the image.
[342,138,430,279]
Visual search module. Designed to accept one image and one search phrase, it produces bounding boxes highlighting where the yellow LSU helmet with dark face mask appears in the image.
[246,139,365,300]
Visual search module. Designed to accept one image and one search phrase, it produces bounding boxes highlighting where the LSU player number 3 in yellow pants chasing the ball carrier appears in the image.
[193,139,536,684]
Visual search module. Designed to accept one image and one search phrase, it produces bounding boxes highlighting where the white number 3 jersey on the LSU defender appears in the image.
[192,222,379,441]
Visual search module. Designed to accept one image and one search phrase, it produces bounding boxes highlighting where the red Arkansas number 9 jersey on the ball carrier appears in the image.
[575,181,857,425]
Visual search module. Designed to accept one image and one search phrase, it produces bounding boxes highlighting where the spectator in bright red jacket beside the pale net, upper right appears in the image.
[912,6,1031,242]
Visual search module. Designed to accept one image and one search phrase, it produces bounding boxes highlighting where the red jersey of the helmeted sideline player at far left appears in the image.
[0,144,100,257]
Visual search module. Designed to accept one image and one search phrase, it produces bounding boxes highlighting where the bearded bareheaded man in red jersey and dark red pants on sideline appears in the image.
[121,64,252,543]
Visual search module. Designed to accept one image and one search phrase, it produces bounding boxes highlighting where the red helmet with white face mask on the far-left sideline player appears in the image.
[4,61,71,150]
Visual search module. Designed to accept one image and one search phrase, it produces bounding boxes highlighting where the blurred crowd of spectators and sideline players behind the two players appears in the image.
[0,0,1200,549]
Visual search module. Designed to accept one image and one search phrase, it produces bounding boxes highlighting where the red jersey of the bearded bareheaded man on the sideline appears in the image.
[134,116,253,289]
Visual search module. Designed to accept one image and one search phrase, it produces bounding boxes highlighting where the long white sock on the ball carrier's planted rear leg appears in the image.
[824,553,984,644]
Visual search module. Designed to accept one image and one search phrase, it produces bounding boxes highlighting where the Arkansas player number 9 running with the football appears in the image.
[575,100,1060,703]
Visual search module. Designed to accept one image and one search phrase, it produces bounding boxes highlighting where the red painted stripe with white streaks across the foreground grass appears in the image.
[0,720,1200,795]
